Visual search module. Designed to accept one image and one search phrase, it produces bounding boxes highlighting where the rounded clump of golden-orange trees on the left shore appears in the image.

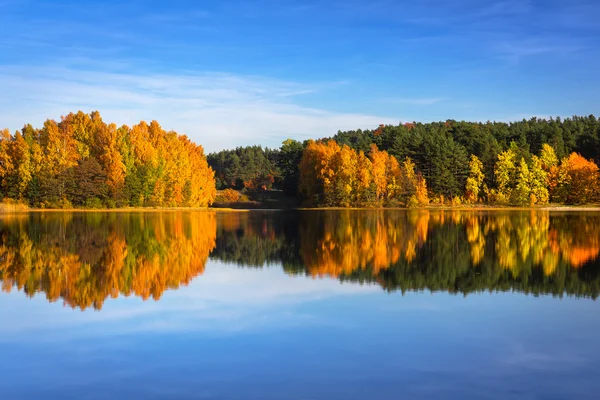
[0,111,216,208]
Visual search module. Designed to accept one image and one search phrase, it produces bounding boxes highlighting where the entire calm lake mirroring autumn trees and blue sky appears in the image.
[0,210,600,400]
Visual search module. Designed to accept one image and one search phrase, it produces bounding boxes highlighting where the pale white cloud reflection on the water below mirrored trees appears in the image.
[0,261,378,341]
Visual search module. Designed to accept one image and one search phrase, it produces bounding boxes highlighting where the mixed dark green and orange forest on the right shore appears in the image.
[208,116,600,207]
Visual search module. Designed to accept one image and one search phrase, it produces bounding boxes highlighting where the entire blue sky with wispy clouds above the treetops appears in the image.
[0,0,600,151]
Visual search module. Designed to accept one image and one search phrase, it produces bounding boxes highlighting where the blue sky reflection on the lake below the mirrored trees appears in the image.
[0,261,600,399]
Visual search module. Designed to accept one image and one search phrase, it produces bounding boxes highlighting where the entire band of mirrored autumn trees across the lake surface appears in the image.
[0,210,600,309]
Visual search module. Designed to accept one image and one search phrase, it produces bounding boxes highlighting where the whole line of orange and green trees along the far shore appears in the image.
[0,111,600,208]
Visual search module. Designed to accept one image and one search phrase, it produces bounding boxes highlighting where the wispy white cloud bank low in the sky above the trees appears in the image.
[0,66,406,152]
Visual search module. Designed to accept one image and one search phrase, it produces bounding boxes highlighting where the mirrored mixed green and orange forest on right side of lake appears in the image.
[211,210,600,297]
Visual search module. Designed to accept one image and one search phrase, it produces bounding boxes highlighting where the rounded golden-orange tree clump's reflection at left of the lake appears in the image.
[0,212,216,309]
